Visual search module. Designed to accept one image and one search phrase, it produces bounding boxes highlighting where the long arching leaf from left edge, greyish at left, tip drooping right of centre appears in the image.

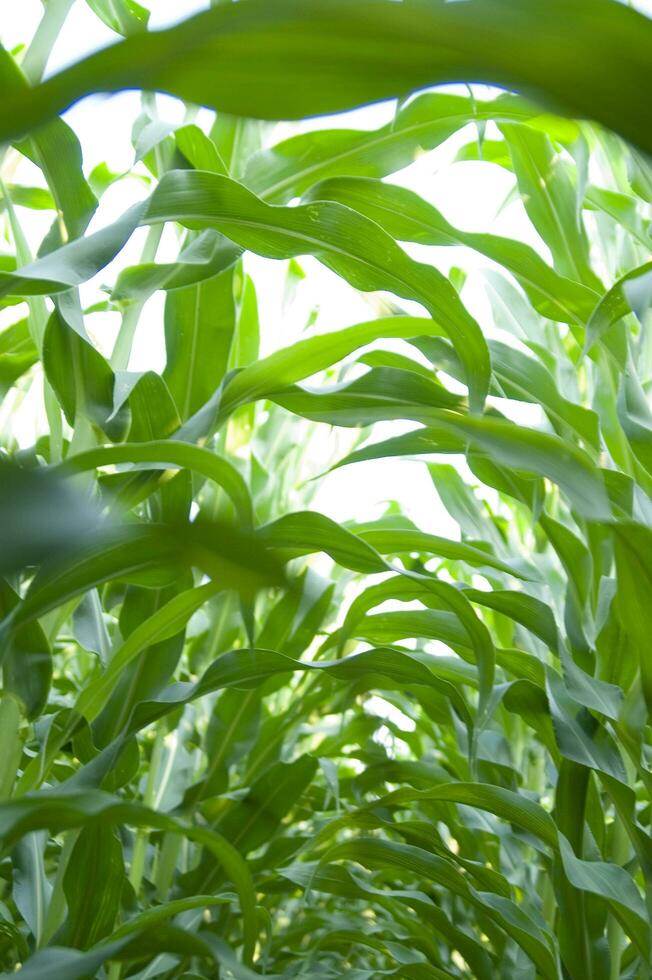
[0,171,489,407]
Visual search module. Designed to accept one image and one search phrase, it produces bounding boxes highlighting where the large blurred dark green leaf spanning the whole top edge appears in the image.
[0,0,651,151]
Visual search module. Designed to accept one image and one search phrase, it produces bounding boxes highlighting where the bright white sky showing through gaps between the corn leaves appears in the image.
[0,0,652,537]
